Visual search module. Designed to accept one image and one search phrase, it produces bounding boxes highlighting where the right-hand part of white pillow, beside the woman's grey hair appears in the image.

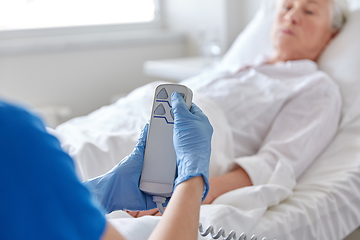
[318,9,360,127]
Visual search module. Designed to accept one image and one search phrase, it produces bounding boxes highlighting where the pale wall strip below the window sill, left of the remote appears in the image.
[0,42,185,122]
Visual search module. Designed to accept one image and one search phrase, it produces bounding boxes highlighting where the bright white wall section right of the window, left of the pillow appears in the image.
[165,0,263,56]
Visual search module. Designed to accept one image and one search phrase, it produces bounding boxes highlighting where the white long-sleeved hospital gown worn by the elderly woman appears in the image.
[184,60,342,185]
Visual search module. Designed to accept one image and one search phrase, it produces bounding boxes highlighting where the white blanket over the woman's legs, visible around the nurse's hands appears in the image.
[56,82,295,240]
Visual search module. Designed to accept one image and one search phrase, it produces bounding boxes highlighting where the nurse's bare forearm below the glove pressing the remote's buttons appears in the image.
[149,177,204,240]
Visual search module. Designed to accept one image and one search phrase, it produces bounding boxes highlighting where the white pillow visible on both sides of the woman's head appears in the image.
[218,0,360,127]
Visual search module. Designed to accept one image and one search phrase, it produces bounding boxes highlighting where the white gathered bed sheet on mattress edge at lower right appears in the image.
[251,115,360,240]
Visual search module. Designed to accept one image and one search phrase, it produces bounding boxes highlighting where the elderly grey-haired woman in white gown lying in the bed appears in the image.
[126,0,349,217]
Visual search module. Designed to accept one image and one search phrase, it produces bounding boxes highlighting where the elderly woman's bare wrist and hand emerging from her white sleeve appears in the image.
[203,167,252,204]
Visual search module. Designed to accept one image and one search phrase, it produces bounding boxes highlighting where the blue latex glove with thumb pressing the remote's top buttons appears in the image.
[171,92,213,200]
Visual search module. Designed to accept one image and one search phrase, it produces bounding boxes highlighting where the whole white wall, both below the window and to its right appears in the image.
[0,0,261,125]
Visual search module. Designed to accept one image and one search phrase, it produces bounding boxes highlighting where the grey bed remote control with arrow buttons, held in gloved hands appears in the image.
[139,84,193,197]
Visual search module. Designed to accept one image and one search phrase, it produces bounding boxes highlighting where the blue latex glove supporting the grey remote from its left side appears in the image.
[84,124,156,213]
